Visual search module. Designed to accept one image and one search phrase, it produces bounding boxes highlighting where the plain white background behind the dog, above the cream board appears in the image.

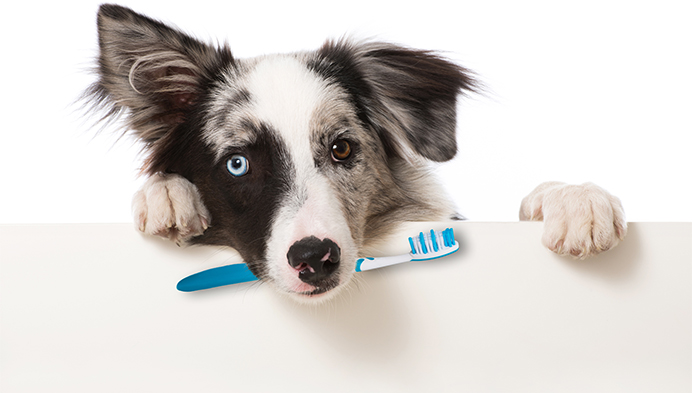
[0,0,692,223]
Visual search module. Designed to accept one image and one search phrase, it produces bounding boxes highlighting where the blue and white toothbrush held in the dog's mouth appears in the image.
[177,228,459,292]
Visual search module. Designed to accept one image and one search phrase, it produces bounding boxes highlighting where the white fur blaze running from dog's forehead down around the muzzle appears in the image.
[246,56,357,299]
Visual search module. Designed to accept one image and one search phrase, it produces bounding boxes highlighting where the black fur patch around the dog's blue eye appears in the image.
[171,121,295,278]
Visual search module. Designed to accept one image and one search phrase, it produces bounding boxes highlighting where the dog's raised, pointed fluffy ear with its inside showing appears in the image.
[87,4,233,145]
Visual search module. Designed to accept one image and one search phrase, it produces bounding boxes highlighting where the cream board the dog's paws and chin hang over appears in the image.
[0,222,692,393]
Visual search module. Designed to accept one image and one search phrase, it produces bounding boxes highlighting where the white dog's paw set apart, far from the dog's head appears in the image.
[519,182,627,259]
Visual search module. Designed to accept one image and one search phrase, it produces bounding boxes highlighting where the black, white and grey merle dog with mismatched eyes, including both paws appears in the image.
[86,4,627,302]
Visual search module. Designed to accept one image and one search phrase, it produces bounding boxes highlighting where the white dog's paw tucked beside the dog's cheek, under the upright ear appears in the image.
[132,173,211,245]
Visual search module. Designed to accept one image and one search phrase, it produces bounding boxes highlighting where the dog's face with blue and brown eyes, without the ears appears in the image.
[197,56,386,297]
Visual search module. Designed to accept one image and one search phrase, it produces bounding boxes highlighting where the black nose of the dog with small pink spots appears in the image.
[286,236,341,284]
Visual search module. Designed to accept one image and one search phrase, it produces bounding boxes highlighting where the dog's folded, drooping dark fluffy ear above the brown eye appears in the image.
[318,40,477,161]
